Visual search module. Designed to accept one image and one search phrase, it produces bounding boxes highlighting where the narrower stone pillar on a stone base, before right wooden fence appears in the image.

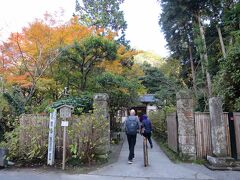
[209,97,227,157]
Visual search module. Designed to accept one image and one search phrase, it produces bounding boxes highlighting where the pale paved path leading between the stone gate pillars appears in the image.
[90,135,213,179]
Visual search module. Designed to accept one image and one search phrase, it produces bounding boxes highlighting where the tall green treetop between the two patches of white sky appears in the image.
[76,0,128,46]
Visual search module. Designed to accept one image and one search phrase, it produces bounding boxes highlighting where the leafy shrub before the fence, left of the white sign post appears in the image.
[0,121,48,164]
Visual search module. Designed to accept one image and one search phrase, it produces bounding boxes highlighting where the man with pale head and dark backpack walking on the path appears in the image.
[124,109,140,164]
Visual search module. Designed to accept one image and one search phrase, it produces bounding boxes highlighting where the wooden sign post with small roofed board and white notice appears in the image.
[60,105,73,170]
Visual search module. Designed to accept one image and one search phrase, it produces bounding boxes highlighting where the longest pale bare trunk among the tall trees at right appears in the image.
[197,15,212,98]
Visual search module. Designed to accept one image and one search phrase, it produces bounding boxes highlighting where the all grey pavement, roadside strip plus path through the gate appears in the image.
[0,136,240,180]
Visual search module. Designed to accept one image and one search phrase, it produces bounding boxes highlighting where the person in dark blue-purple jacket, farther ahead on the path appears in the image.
[141,114,153,148]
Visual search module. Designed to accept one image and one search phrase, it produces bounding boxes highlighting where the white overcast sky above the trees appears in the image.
[0,0,169,57]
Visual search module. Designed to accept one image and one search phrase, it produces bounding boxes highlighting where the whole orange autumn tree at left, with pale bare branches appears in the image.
[0,14,93,108]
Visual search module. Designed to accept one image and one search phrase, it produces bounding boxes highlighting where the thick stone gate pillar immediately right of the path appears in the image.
[176,91,196,159]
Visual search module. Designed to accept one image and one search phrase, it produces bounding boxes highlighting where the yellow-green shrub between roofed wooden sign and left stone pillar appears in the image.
[68,109,110,165]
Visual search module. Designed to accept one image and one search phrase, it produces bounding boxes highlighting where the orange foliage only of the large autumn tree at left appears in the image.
[0,14,96,87]
